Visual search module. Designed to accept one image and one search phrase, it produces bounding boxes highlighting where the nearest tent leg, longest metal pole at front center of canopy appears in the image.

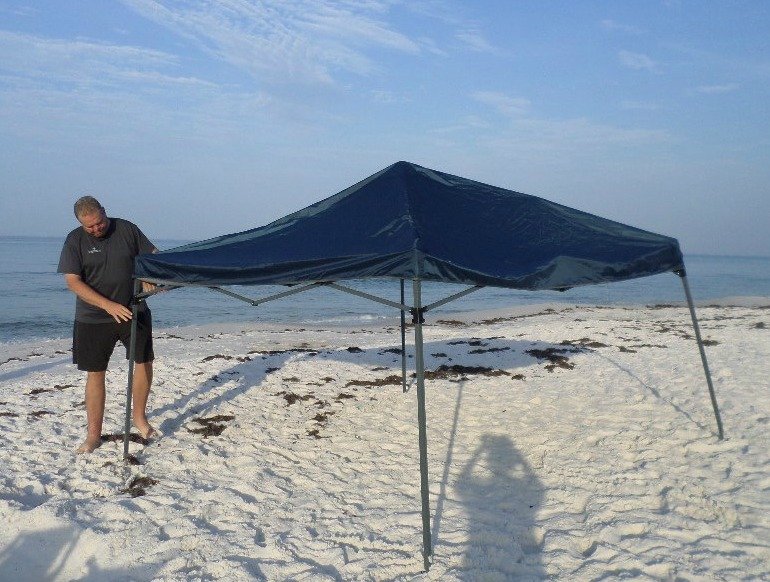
[412,279,433,572]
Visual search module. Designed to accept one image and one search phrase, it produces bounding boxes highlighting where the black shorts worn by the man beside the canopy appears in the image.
[72,311,155,372]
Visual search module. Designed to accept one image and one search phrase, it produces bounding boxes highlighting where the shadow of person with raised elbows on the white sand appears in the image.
[454,433,546,580]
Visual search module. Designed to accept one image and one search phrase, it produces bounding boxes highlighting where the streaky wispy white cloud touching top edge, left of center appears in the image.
[123,0,420,84]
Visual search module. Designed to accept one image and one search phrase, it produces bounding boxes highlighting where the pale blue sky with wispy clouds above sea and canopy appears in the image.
[0,0,770,256]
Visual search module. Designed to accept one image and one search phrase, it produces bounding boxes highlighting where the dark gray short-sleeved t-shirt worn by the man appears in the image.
[57,218,155,323]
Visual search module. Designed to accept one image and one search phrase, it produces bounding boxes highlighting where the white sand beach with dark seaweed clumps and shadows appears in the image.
[0,305,770,581]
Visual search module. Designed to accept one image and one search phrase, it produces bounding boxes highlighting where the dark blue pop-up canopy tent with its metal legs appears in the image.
[124,162,723,570]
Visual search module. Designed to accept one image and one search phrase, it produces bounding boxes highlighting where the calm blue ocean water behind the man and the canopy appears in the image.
[0,237,770,342]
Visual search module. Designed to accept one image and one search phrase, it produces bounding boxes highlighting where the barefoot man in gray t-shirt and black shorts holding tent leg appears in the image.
[58,196,156,453]
